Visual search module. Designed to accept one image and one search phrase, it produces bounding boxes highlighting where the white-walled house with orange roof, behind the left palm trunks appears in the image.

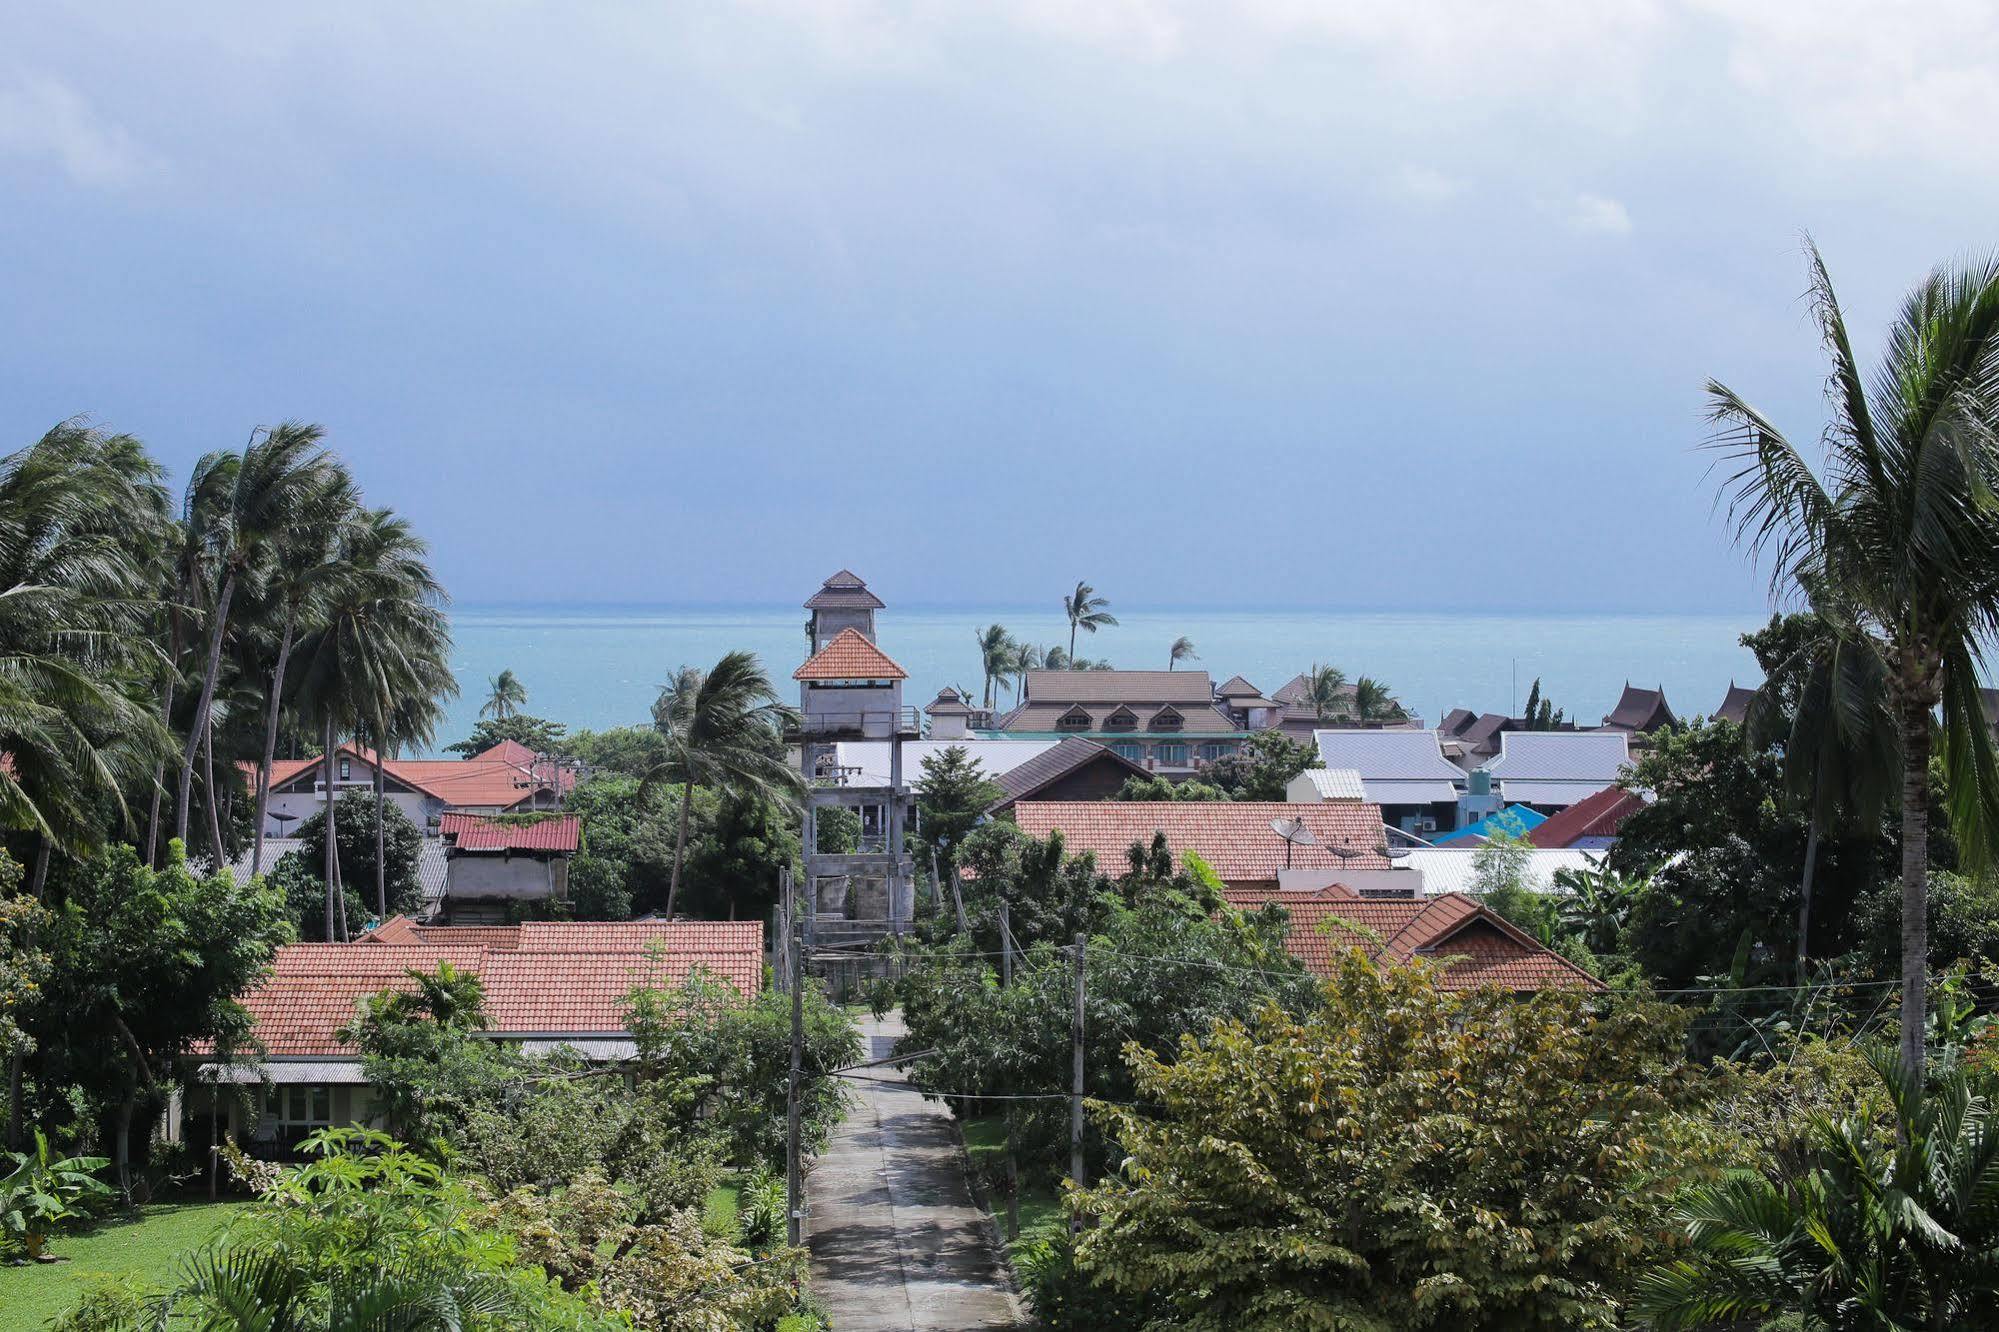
[242,740,576,836]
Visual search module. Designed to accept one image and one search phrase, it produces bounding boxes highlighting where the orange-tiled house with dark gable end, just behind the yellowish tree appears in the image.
[1225,884,1603,994]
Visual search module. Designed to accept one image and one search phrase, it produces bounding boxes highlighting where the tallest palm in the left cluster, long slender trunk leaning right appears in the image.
[174,422,334,842]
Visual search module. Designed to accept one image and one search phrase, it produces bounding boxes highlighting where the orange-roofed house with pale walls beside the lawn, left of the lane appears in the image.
[168,916,764,1150]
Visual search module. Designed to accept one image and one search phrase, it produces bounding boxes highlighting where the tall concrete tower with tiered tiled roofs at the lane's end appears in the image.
[790,570,924,944]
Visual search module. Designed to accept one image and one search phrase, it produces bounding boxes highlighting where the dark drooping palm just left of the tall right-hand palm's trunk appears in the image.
[1743,608,1899,984]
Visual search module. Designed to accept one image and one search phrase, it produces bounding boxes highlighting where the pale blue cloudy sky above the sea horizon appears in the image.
[0,0,1999,610]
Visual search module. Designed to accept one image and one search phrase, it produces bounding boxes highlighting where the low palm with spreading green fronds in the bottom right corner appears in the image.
[1633,1052,1999,1332]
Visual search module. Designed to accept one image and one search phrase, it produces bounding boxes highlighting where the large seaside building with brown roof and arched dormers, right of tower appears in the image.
[996,670,1253,776]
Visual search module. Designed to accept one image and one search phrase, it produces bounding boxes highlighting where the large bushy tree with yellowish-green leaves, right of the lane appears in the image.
[1073,950,1679,1332]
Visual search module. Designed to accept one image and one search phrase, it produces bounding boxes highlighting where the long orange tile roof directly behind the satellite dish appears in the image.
[1013,800,1389,884]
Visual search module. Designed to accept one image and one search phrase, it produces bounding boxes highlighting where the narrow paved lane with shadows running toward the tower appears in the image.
[806,1014,1027,1332]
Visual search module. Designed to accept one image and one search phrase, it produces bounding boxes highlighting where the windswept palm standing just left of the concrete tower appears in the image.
[640,652,804,920]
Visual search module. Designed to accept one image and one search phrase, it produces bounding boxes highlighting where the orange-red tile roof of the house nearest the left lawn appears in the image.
[229,918,764,1058]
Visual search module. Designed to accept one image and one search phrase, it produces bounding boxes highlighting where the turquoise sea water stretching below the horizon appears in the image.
[440,604,1763,744]
